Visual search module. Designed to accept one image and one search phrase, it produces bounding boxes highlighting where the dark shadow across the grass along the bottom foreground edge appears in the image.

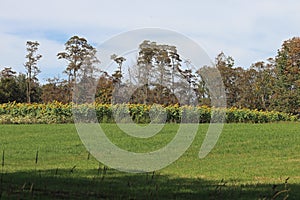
[1,167,300,200]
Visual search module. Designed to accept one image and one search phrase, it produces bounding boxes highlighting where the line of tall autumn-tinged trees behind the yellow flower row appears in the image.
[0,36,300,114]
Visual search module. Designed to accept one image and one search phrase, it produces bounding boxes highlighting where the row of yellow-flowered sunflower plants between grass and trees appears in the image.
[0,102,297,124]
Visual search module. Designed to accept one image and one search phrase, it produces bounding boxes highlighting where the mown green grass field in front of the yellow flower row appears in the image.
[0,123,300,200]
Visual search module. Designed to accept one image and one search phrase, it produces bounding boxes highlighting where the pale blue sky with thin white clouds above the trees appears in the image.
[0,0,300,82]
